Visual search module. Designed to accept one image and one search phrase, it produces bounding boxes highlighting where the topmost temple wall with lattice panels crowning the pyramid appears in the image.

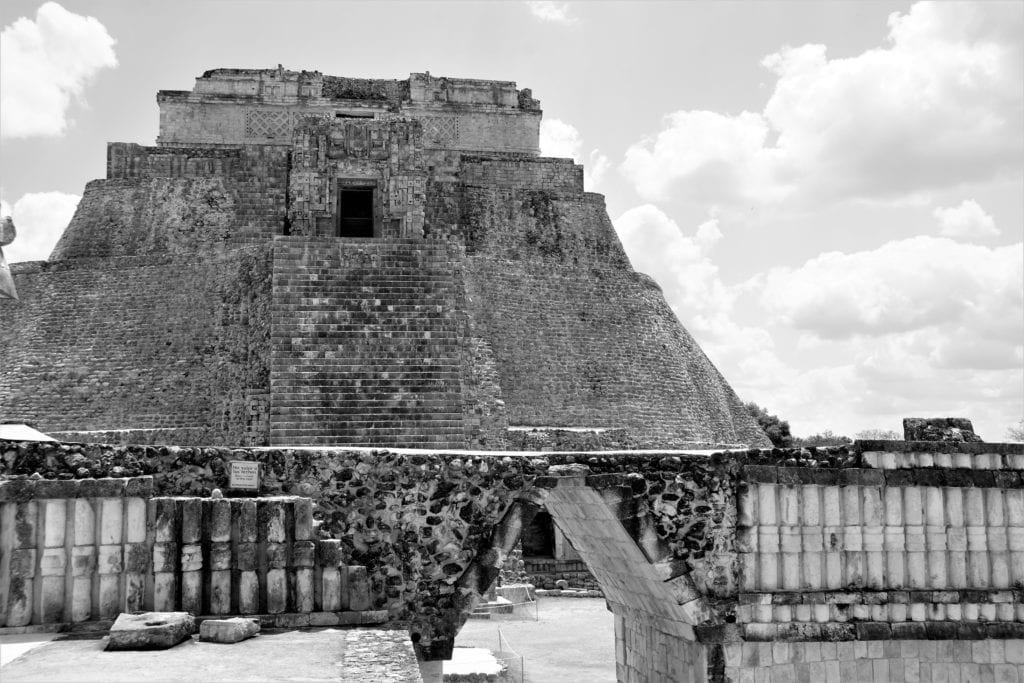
[157,70,541,155]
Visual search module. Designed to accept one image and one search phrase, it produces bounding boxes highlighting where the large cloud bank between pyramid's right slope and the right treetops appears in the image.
[613,205,1024,439]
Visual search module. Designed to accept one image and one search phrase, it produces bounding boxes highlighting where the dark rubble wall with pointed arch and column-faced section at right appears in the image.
[6,441,1024,681]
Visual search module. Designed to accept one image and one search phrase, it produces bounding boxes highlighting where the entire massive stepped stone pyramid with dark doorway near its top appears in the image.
[0,67,768,450]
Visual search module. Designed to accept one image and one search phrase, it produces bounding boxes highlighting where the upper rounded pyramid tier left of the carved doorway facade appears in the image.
[50,142,288,260]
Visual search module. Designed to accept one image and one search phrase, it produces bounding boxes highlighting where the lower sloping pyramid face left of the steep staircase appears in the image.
[0,249,270,444]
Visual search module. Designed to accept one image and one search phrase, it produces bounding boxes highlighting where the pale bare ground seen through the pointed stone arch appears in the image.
[455,597,615,683]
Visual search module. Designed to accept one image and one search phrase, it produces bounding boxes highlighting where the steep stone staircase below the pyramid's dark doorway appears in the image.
[270,238,465,447]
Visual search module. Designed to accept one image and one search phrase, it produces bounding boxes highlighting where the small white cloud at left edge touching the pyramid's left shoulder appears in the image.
[0,193,82,263]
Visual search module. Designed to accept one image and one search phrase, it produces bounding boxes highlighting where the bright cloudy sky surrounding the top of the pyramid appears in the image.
[0,0,1024,440]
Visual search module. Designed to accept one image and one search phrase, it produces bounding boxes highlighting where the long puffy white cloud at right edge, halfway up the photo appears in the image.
[759,237,1024,346]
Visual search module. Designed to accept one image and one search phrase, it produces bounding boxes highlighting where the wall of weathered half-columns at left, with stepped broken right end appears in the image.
[0,477,387,631]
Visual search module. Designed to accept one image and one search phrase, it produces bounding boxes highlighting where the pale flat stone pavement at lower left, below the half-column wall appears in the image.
[0,629,422,683]
